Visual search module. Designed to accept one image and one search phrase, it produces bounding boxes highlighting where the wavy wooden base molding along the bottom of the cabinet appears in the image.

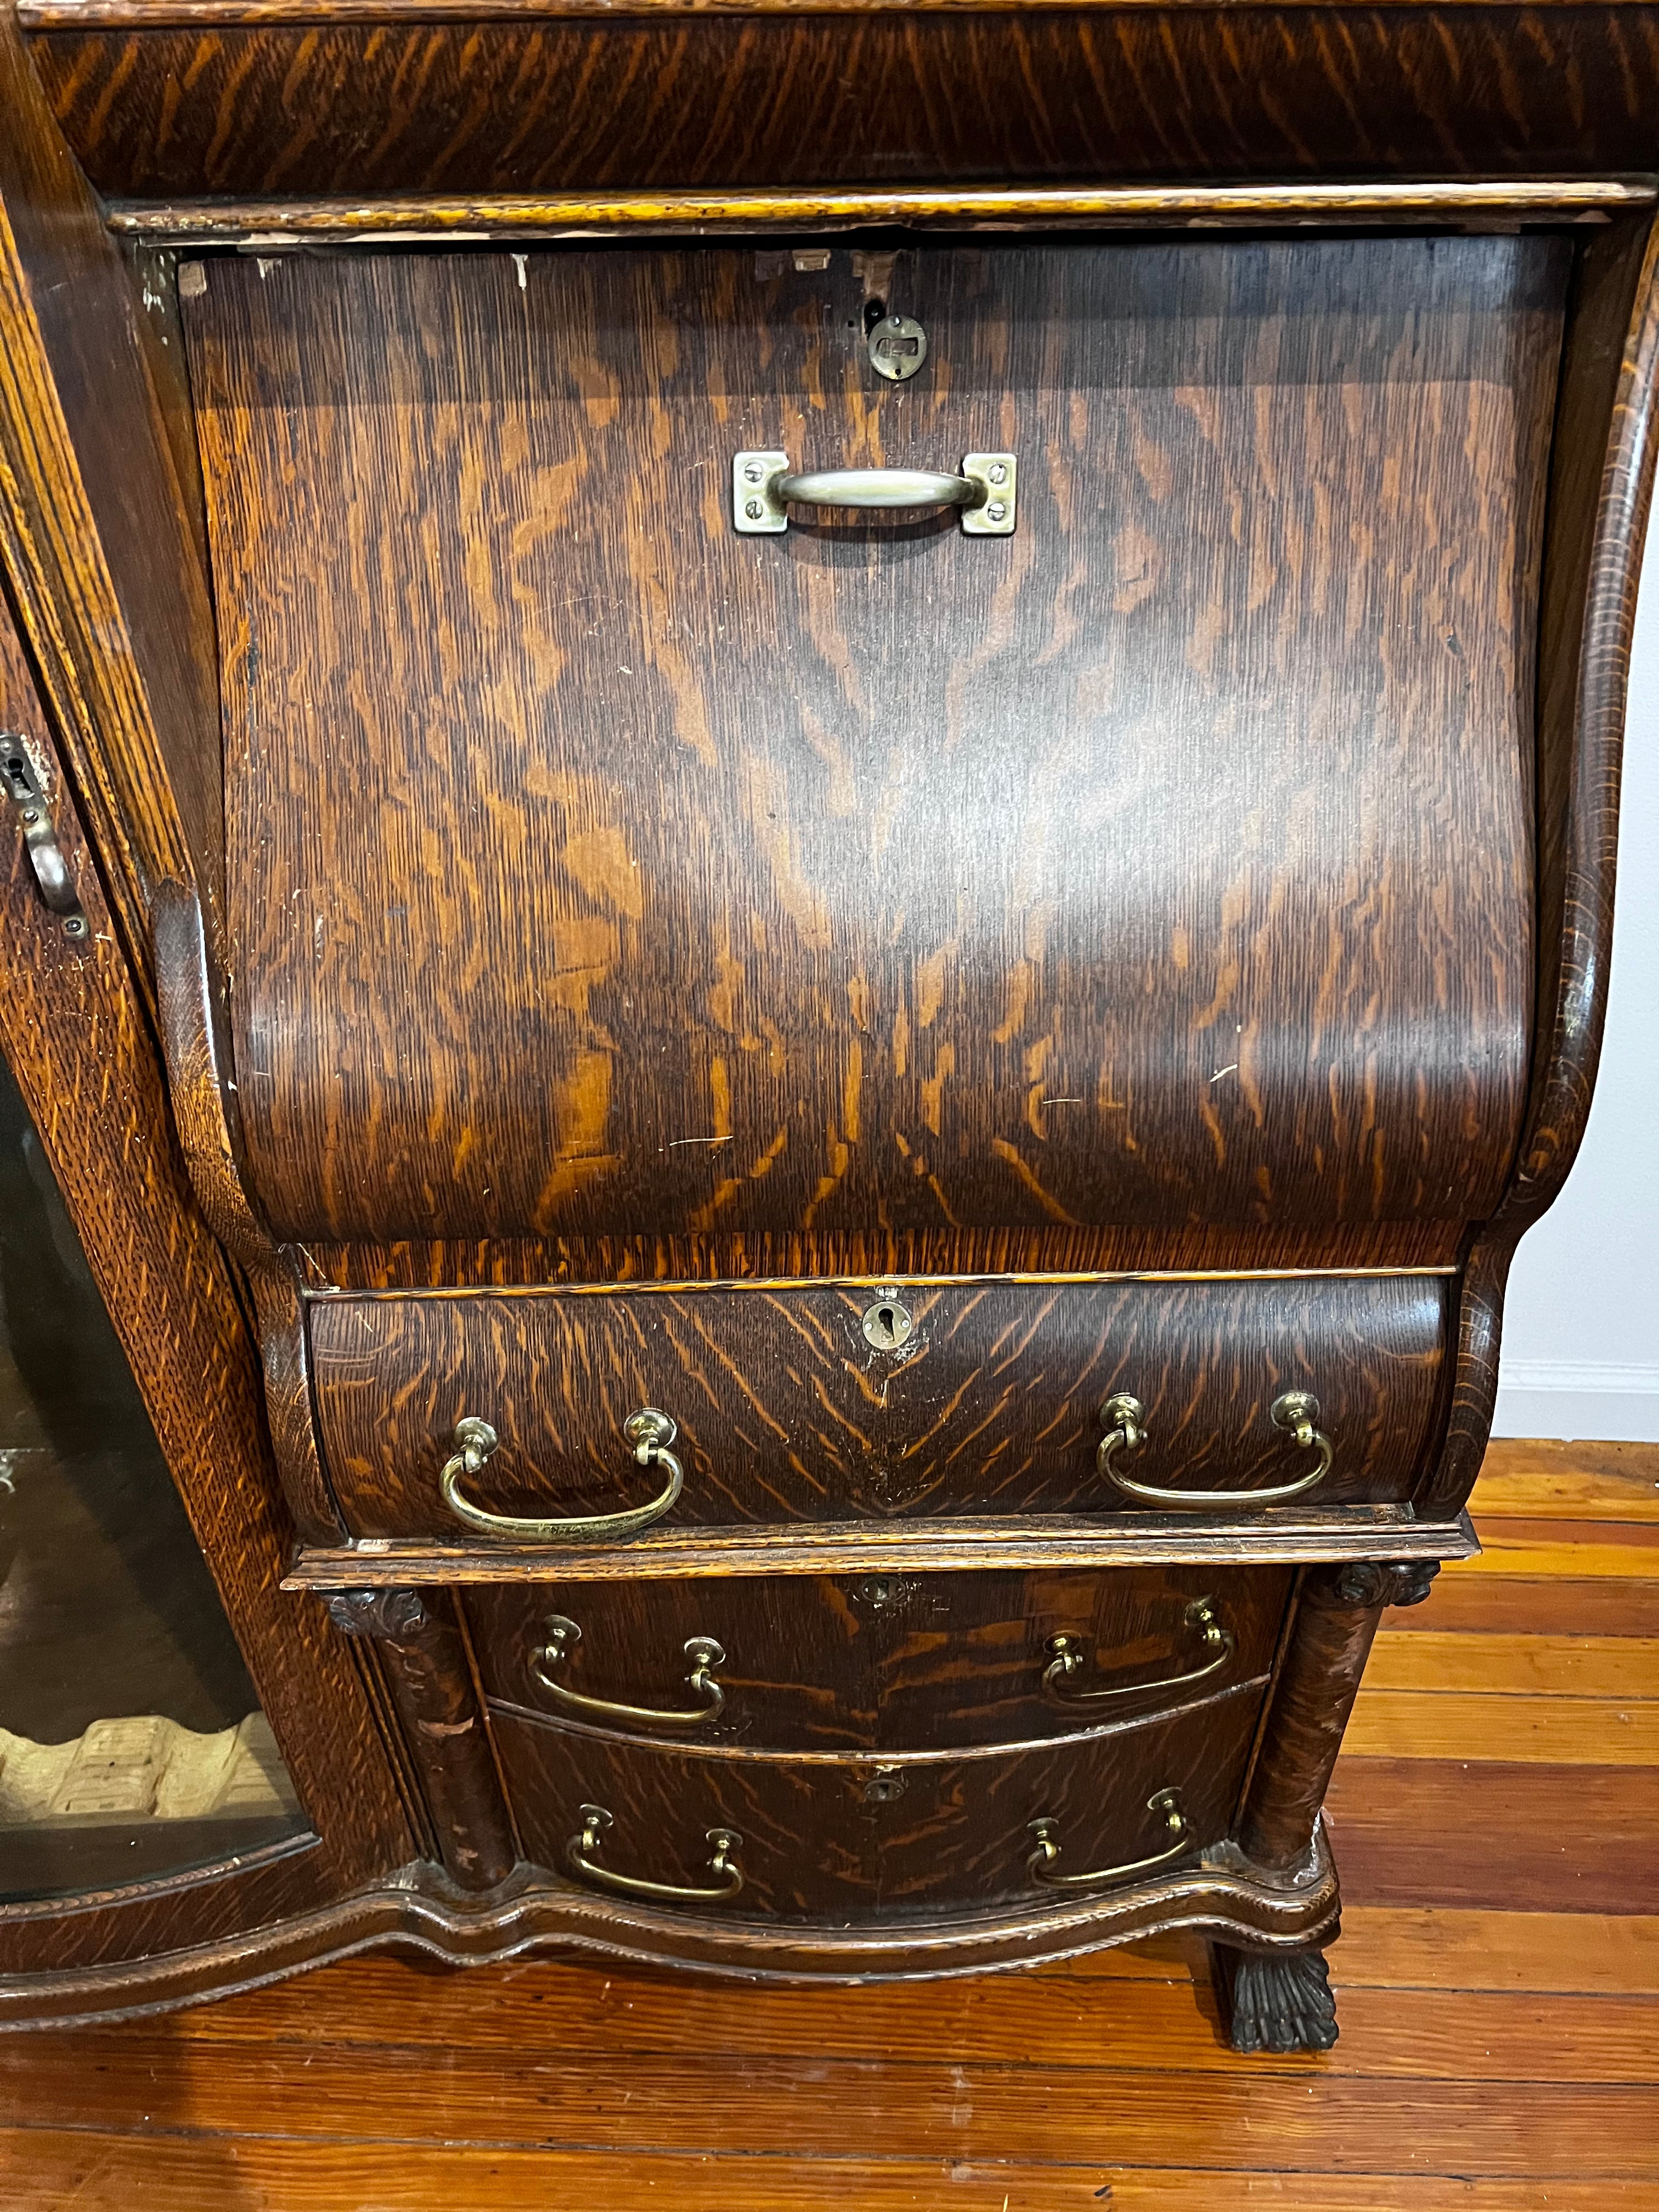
[0,1829,1340,2049]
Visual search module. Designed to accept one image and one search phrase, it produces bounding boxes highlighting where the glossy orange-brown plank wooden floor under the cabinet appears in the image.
[0,1444,1659,2212]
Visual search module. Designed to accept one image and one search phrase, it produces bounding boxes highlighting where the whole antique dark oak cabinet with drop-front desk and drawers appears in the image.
[0,0,1659,2051]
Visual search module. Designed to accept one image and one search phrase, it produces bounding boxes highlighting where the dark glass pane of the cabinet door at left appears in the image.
[0,1035,307,1903]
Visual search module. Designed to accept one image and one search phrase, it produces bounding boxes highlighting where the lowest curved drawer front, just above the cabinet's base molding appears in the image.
[495,1685,1261,1925]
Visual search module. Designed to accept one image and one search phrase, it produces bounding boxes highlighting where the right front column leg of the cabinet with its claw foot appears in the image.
[1215,1560,1440,2051]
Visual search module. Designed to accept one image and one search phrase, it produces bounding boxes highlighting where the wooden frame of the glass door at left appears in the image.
[0,584,411,1973]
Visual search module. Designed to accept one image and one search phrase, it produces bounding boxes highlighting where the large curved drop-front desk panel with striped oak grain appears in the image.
[186,236,1566,1239]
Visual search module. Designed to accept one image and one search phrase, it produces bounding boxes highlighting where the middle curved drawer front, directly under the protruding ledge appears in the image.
[465,1566,1290,1752]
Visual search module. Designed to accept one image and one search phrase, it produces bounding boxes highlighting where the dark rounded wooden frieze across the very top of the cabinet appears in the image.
[33,4,1659,197]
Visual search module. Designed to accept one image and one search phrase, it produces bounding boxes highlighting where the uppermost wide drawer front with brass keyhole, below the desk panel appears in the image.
[309,1276,1449,1537]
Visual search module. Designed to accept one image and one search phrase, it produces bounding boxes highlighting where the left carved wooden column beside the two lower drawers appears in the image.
[328,1590,517,1889]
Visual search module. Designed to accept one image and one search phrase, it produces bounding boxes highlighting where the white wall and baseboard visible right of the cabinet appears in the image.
[1493,528,1659,1442]
